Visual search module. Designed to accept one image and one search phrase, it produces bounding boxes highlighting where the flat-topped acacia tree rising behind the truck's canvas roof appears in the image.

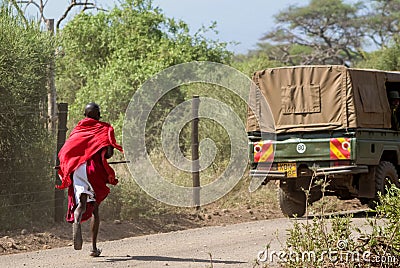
[256,0,363,65]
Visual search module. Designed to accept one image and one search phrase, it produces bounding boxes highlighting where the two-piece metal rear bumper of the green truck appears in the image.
[250,166,368,180]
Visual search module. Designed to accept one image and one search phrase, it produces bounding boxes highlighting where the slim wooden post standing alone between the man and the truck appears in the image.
[192,96,200,210]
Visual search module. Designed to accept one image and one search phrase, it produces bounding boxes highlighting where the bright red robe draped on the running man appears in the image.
[56,118,122,222]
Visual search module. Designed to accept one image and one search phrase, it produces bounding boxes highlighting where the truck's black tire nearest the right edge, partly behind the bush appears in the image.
[368,161,400,209]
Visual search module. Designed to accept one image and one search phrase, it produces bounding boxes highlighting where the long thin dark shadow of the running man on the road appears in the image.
[101,256,246,264]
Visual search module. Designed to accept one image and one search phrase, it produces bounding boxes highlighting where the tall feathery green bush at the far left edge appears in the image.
[0,6,54,229]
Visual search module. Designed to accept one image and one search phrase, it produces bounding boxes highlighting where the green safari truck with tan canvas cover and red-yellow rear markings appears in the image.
[247,65,400,217]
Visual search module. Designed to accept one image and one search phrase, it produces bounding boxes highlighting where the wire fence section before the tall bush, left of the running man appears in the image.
[0,103,64,231]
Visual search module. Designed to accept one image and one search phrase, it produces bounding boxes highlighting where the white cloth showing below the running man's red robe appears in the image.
[72,163,96,204]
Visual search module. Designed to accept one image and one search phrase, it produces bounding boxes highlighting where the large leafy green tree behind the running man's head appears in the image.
[57,0,231,141]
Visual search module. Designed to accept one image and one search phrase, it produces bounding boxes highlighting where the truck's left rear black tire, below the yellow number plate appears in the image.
[279,188,306,218]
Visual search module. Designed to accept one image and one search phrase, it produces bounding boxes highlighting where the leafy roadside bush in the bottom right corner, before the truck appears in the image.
[274,185,400,267]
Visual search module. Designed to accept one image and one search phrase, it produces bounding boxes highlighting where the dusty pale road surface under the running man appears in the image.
[0,218,365,268]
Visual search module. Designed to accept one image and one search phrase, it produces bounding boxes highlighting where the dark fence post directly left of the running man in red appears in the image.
[54,103,68,222]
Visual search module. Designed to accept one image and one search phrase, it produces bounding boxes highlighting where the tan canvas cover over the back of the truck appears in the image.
[247,65,400,133]
